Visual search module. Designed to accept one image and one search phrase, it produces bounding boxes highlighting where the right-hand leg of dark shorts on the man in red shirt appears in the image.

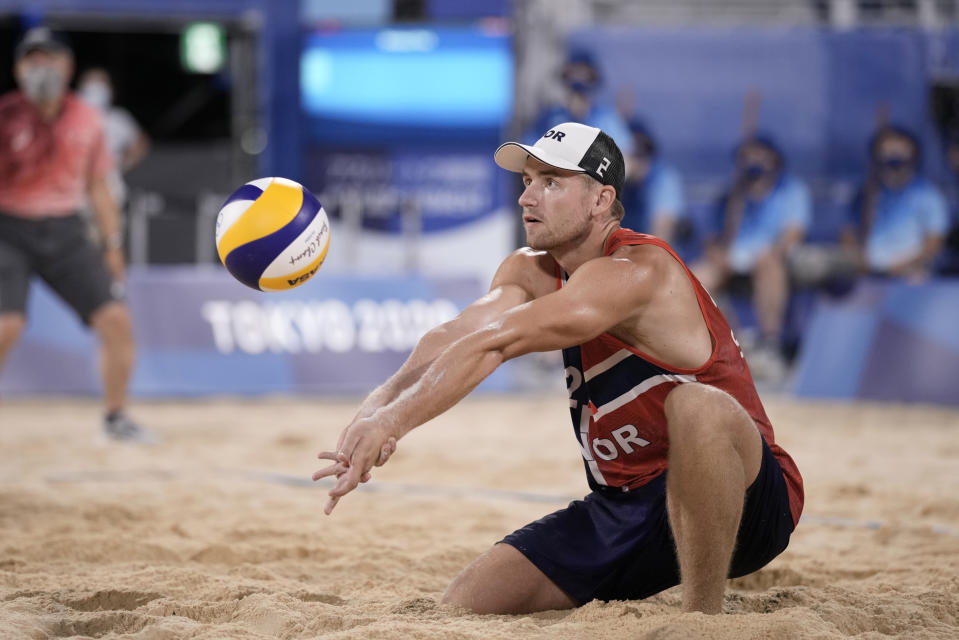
[36,216,120,324]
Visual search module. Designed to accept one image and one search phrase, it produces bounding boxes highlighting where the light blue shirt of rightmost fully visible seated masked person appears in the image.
[866,177,949,271]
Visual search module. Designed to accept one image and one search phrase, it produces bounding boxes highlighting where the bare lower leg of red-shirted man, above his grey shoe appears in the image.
[90,301,134,413]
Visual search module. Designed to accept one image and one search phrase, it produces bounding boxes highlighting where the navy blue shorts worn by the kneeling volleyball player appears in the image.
[501,439,793,604]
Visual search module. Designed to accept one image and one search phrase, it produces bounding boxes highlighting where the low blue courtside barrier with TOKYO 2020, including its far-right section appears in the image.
[0,266,959,405]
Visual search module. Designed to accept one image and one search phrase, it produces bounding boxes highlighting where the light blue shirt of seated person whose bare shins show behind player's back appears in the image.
[729,174,812,273]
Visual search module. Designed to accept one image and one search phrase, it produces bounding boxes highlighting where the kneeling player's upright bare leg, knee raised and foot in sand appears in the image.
[665,383,763,613]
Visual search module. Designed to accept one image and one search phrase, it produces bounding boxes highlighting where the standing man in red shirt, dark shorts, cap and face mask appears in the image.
[0,27,152,442]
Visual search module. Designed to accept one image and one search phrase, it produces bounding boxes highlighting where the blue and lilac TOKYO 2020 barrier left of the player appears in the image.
[0,267,508,396]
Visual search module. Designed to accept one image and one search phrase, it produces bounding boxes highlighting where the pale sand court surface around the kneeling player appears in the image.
[0,390,959,639]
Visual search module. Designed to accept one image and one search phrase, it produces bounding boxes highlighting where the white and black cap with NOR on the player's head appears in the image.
[493,122,626,199]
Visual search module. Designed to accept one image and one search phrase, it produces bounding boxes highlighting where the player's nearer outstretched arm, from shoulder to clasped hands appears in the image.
[314,258,651,513]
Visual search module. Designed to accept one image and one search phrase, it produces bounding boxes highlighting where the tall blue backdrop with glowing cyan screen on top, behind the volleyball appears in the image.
[299,21,519,282]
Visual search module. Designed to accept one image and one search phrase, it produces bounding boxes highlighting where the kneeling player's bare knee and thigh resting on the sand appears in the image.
[442,543,579,614]
